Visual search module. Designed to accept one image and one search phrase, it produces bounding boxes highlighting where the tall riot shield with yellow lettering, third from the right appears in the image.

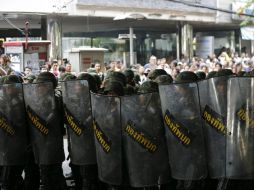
[159,83,207,180]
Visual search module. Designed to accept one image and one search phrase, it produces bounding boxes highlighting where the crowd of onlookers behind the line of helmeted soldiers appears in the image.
[0,48,254,88]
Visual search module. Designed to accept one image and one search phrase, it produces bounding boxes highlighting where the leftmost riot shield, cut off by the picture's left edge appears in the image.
[0,83,28,166]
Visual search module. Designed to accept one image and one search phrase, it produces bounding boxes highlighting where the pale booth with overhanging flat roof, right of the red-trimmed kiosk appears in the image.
[69,47,108,73]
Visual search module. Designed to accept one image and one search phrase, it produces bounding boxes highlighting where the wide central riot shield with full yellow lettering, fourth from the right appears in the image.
[121,93,170,187]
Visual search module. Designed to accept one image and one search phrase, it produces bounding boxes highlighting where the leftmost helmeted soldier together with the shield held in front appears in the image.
[0,75,28,190]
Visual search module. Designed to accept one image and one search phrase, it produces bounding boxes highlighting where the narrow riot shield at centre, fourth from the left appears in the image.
[91,93,122,185]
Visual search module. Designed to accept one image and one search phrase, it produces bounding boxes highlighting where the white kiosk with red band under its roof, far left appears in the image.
[3,41,50,74]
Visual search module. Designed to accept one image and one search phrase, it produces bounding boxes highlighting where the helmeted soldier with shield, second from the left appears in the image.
[24,72,66,190]
